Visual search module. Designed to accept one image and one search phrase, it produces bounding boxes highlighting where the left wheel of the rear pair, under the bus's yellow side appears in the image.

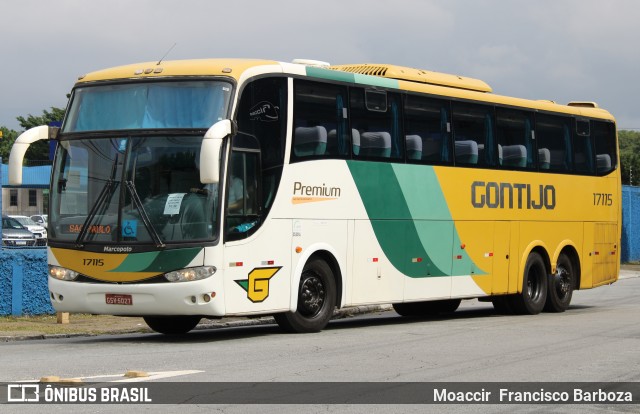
[508,252,548,315]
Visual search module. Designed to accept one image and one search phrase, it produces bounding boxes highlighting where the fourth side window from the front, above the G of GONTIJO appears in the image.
[452,102,498,166]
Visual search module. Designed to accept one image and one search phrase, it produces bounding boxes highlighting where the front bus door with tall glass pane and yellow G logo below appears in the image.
[223,146,291,314]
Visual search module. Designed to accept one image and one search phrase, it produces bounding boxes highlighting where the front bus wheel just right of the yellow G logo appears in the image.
[274,259,336,333]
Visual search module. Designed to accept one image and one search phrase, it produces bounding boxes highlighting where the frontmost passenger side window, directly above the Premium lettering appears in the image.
[291,80,351,161]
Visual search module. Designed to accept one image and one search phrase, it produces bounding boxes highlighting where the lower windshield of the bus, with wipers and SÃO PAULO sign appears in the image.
[49,134,218,246]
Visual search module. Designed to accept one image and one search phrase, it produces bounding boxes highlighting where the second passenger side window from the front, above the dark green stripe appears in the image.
[349,88,404,160]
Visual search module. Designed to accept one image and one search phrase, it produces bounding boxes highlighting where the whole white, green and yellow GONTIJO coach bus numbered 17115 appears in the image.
[10,59,621,334]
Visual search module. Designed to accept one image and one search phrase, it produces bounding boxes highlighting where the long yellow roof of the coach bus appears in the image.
[76,59,614,121]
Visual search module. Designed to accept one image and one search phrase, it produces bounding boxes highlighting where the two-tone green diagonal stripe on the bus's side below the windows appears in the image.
[347,161,480,278]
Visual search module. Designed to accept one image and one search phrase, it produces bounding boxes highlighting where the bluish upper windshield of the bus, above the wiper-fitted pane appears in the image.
[62,80,231,133]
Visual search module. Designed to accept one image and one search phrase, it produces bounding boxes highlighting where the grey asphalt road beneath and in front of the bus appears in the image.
[0,278,640,414]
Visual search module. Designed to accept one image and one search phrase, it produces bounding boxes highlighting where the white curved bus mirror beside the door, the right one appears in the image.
[200,119,235,184]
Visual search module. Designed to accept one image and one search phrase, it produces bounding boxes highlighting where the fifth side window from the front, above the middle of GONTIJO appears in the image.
[496,108,537,169]
